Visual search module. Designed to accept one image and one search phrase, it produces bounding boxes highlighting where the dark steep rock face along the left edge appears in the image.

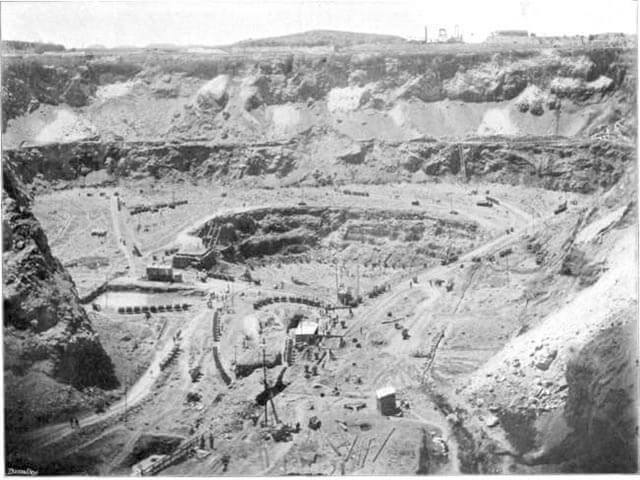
[2,162,118,431]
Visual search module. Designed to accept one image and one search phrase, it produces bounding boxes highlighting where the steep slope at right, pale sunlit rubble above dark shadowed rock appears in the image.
[461,188,638,473]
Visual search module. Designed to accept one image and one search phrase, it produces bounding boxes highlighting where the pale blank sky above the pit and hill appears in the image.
[0,0,638,48]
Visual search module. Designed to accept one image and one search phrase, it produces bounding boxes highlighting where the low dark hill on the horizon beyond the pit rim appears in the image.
[233,30,406,47]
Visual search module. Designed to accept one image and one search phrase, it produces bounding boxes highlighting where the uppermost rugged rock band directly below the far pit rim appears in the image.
[2,46,633,135]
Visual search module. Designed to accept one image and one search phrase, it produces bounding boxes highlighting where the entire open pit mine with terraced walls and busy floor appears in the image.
[2,32,638,476]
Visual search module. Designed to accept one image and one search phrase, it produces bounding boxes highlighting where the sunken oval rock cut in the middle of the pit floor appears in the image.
[195,207,481,267]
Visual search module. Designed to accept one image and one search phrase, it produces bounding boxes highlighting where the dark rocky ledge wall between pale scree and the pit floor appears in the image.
[5,138,633,193]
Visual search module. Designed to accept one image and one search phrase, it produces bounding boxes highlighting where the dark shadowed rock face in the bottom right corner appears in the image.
[557,324,638,473]
